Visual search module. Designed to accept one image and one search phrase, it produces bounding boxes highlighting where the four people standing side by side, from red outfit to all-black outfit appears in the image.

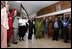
[7,9,35,46]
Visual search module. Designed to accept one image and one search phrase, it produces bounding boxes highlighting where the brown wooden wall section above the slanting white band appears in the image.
[37,1,71,16]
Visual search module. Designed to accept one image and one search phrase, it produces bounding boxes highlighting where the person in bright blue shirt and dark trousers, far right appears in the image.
[61,18,69,43]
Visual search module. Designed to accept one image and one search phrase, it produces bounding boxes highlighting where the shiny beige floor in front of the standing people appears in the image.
[8,33,71,48]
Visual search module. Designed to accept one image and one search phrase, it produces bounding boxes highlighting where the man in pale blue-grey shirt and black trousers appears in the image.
[52,18,59,40]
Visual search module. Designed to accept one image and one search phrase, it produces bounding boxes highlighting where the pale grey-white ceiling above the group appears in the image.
[8,1,59,15]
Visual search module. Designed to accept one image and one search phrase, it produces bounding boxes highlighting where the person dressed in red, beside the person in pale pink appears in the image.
[7,9,16,46]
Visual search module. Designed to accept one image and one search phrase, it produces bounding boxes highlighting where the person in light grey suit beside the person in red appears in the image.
[13,9,19,44]
